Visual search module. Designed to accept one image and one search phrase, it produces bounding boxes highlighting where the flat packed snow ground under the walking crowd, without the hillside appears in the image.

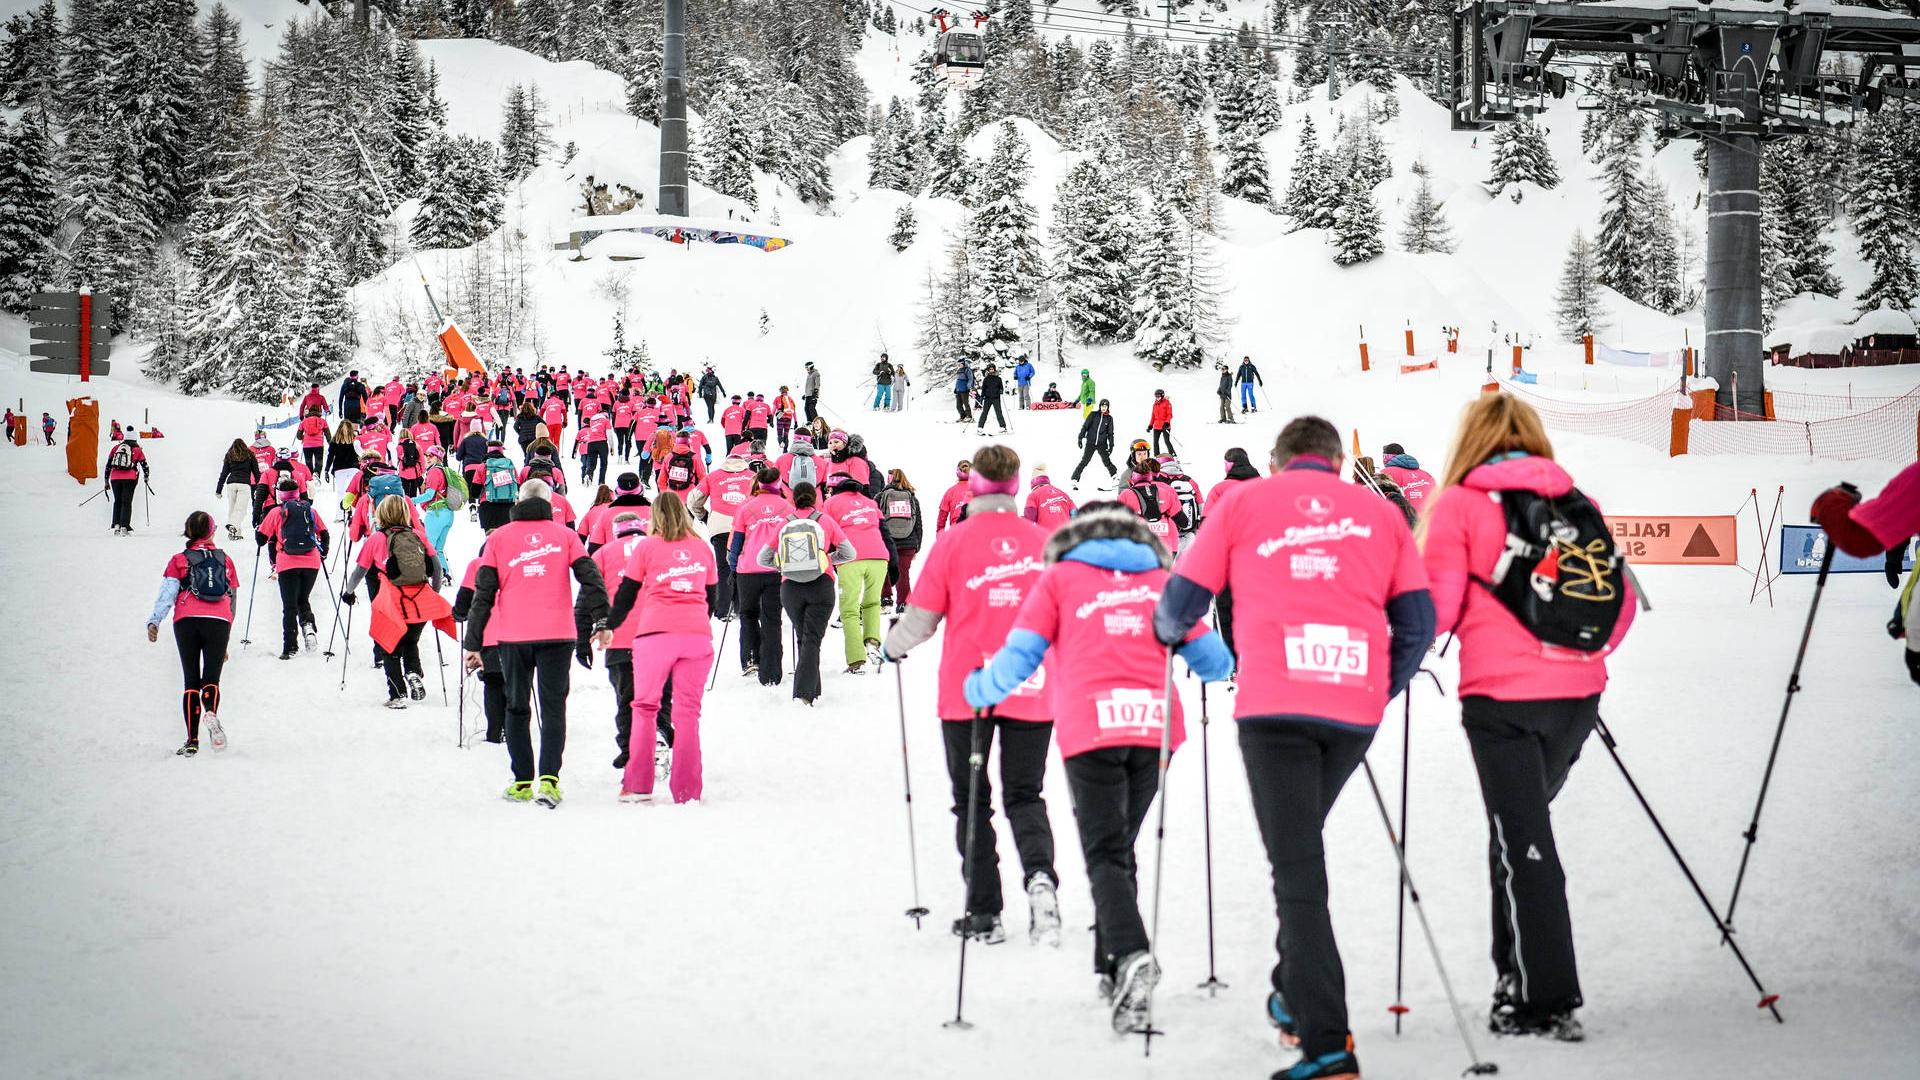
[0,345,1920,1078]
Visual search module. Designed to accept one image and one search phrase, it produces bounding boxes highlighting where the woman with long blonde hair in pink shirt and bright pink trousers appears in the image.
[607,492,718,803]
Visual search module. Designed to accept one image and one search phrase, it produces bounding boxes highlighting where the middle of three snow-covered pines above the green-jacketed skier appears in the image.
[1052,156,1137,344]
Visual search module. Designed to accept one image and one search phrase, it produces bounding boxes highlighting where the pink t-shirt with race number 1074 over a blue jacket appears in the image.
[1021,561,1208,757]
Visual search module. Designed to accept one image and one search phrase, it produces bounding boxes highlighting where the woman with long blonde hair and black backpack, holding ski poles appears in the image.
[1421,394,1634,1042]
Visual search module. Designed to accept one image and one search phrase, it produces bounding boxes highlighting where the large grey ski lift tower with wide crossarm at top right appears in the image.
[1452,0,1920,413]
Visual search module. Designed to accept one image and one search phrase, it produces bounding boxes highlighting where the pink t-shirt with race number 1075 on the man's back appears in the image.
[1175,457,1427,728]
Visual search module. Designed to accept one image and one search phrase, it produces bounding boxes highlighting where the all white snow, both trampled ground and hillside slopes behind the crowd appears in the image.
[0,0,1920,1080]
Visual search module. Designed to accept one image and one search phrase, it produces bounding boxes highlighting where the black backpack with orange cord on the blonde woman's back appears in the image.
[1475,488,1626,653]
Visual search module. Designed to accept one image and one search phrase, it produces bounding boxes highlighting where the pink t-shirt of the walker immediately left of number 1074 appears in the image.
[910,513,1054,721]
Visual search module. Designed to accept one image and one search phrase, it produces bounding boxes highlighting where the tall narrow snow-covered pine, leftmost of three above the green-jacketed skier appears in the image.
[968,121,1043,359]
